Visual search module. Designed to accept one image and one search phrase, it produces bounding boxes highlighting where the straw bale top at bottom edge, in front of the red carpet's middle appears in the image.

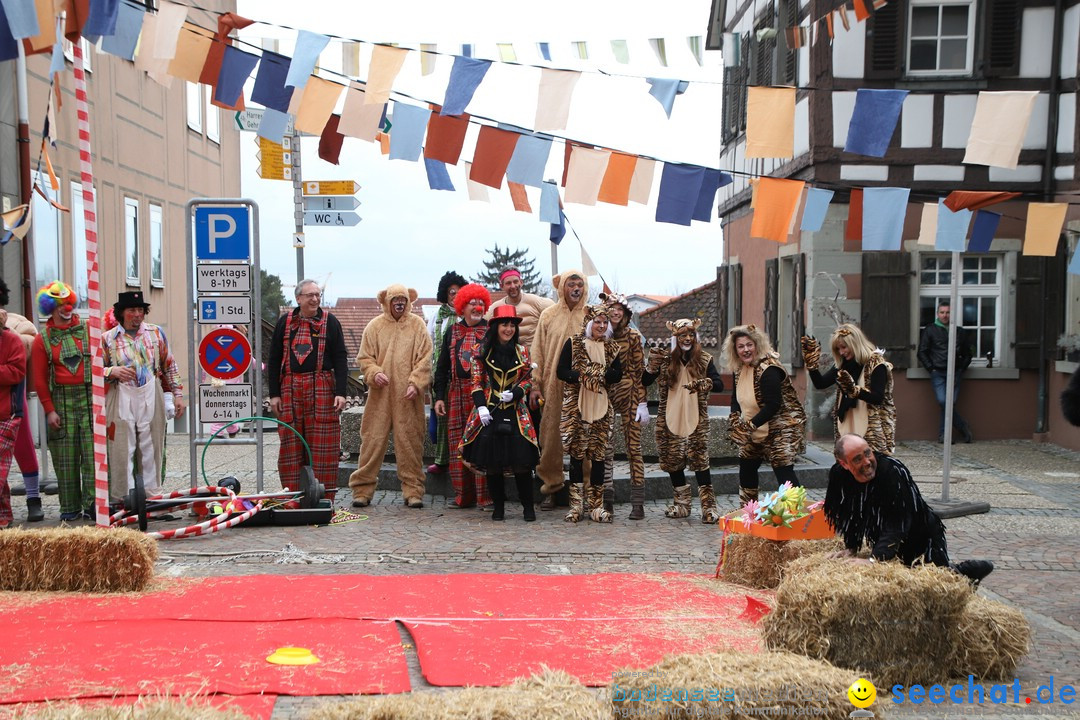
[308,668,611,720]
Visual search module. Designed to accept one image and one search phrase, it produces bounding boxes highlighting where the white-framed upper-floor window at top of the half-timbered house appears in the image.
[907,0,975,74]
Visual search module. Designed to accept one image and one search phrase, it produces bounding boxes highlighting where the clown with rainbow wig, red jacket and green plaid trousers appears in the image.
[30,281,94,520]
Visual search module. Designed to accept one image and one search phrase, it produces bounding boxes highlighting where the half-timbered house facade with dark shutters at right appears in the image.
[711,0,1080,448]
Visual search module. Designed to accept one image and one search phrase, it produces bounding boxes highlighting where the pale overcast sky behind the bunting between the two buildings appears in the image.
[238,0,723,300]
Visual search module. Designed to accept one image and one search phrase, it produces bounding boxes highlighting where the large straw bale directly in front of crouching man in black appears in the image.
[761,555,973,687]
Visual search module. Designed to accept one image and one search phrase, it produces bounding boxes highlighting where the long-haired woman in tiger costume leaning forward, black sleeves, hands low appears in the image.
[720,325,807,504]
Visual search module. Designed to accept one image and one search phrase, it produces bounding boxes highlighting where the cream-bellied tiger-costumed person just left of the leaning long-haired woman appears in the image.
[642,317,724,524]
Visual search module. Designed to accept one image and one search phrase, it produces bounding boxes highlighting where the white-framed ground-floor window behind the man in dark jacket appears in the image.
[919,255,1003,367]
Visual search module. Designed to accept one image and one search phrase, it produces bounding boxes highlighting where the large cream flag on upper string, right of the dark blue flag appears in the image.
[963,90,1039,169]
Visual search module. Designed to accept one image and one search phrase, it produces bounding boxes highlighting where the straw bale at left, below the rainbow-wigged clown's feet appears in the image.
[0,527,158,593]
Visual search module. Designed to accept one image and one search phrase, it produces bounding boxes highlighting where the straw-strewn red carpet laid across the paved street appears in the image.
[0,573,767,704]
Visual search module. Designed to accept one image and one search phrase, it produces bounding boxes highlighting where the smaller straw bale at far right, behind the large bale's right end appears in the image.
[949,595,1031,680]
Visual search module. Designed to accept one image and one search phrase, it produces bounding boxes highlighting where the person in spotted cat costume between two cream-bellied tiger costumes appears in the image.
[599,293,650,520]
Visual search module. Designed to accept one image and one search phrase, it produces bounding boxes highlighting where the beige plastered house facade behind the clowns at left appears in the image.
[0,0,240,427]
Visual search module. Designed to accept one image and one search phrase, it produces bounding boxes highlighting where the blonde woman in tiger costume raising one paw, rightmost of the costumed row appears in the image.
[802,323,896,456]
